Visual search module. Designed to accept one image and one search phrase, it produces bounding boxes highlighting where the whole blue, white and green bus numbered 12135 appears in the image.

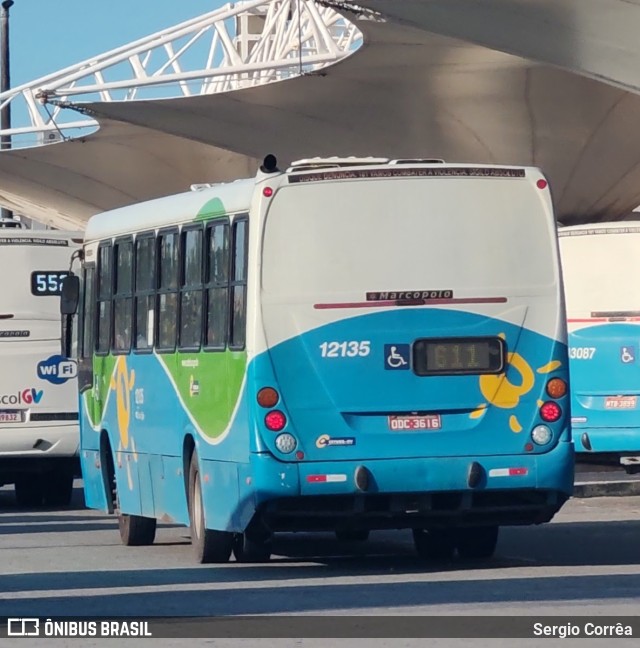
[63,156,573,562]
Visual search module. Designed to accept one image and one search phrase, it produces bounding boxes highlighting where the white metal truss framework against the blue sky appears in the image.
[0,0,362,149]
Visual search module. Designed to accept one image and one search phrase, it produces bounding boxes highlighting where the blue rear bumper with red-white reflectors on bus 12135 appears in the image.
[252,442,574,531]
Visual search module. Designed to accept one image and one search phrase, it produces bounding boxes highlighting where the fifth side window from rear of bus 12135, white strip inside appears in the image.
[134,234,156,351]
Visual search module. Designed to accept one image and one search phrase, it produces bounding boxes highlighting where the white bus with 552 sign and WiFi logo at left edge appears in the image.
[0,222,82,507]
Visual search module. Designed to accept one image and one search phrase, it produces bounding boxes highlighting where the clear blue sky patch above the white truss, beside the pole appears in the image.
[9,0,227,87]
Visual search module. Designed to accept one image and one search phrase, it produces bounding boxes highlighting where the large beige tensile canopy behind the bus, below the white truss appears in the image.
[0,0,640,226]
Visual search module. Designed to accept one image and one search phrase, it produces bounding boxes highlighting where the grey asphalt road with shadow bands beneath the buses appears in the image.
[0,480,640,648]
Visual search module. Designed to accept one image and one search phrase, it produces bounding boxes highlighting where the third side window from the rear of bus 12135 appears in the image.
[179,227,202,350]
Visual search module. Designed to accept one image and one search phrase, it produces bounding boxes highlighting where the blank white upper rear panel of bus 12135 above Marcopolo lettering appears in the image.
[262,179,558,301]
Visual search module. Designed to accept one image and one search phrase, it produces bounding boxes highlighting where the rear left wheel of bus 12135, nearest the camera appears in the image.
[188,450,234,563]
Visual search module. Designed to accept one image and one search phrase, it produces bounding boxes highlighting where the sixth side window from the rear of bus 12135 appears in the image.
[113,238,133,353]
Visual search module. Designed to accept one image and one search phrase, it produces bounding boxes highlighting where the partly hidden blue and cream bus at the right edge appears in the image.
[558,221,640,472]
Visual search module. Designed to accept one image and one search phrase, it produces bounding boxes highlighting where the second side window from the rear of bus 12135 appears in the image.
[205,219,229,349]
